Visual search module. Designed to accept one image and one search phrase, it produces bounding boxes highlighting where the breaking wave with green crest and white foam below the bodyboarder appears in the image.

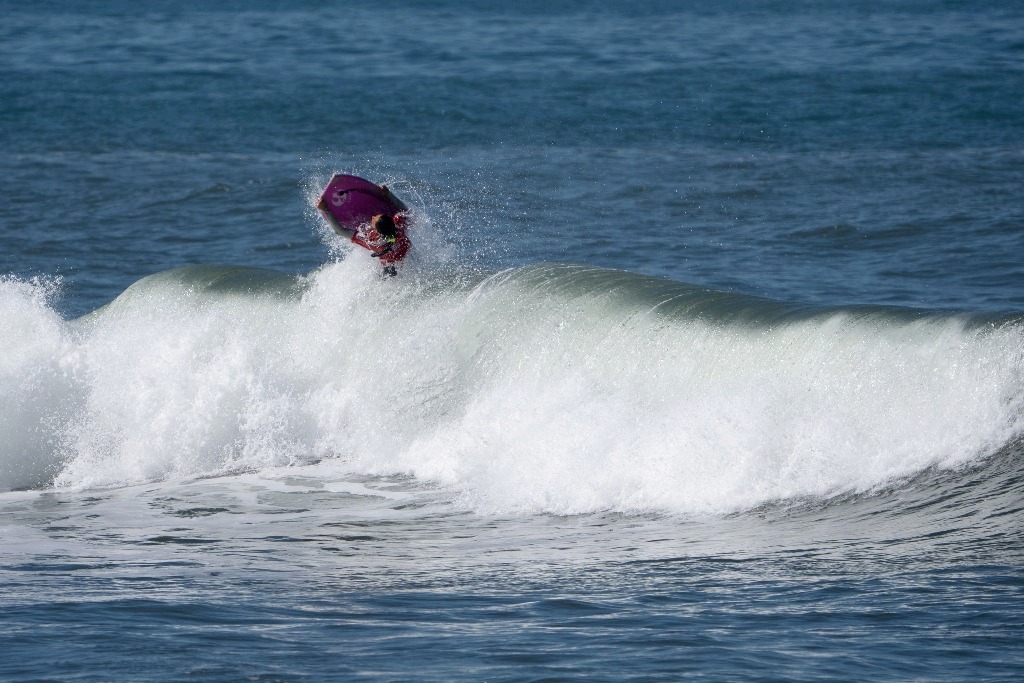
[0,258,1024,514]
